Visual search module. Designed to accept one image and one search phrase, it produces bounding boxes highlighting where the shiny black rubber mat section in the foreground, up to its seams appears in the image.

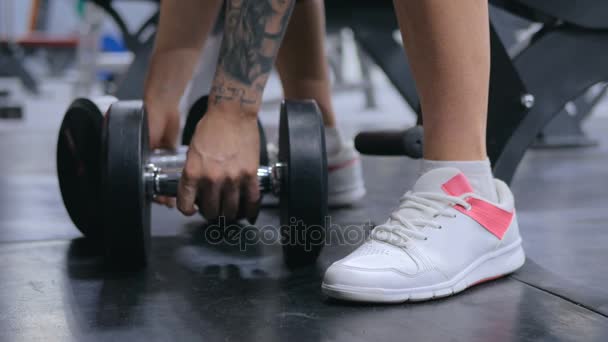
[0,237,608,341]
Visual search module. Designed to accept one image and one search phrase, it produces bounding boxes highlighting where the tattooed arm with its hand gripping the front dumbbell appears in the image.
[177,0,295,222]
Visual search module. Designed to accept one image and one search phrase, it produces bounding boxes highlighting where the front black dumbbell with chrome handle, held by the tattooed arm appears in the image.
[58,97,327,268]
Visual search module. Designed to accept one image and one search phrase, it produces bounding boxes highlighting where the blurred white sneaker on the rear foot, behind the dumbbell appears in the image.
[265,143,365,207]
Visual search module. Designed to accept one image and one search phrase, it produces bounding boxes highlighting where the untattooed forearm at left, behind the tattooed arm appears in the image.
[144,0,222,103]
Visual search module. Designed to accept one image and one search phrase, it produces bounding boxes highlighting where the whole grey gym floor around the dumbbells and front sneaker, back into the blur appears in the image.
[0,73,608,342]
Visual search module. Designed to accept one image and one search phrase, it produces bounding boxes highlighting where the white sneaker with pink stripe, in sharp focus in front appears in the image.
[322,168,525,303]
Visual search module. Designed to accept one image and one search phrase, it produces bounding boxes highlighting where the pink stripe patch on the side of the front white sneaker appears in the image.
[441,173,513,240]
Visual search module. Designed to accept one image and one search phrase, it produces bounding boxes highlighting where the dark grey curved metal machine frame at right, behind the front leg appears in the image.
[488,25,608,181]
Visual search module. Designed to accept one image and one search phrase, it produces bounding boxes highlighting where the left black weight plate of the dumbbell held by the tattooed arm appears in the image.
[101,101,150,269]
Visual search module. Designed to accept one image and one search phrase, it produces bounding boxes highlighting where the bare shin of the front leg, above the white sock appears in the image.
[394,0,490,161]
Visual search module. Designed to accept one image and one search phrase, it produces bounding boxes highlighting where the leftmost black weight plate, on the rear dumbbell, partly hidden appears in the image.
[56,99,103,242]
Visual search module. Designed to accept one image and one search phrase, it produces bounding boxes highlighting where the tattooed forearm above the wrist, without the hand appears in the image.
[210,0,295,115]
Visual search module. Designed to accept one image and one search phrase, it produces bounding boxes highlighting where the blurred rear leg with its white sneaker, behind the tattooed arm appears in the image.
[275,0,365,206]
